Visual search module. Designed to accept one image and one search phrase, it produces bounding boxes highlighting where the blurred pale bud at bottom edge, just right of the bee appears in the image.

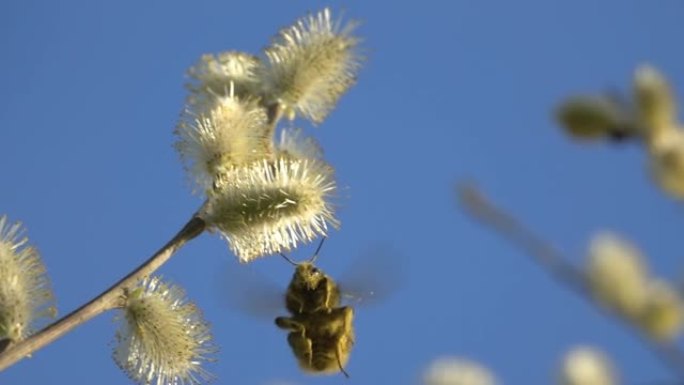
[423,357,497,385]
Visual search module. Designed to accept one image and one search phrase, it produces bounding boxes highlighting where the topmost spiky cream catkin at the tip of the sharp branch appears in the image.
[265,8,361,123]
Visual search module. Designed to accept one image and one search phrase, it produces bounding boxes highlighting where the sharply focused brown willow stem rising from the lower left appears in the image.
[0,216,206,371]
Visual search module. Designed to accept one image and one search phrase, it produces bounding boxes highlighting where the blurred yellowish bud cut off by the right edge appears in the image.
[648,128,684,199]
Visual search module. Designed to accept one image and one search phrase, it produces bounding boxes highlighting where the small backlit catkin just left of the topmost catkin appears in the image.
[187,51,262,109]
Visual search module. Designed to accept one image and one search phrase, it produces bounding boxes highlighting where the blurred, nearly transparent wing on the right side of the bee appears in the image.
[338,245,407,306]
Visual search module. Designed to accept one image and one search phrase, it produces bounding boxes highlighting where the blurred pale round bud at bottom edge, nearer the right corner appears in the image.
[558,346,617,385]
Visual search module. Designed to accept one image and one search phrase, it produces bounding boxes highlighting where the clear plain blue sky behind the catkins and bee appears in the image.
[0,0,684,385]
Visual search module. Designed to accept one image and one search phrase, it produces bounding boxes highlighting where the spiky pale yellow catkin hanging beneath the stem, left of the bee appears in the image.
[113,277,216,385]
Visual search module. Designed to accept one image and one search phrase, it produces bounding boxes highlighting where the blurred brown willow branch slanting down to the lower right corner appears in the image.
[457,185,684,379]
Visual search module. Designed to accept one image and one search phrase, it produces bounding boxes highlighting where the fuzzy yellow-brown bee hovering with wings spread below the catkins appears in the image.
[219,238,405,377]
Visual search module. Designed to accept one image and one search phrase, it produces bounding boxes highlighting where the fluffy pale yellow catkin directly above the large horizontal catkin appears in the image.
[175,93,272,191]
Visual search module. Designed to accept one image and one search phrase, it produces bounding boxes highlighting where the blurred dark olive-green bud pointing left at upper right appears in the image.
[556,95,637,140]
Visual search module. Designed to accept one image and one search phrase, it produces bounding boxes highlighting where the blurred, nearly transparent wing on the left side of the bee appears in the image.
[215,263,285,319]
